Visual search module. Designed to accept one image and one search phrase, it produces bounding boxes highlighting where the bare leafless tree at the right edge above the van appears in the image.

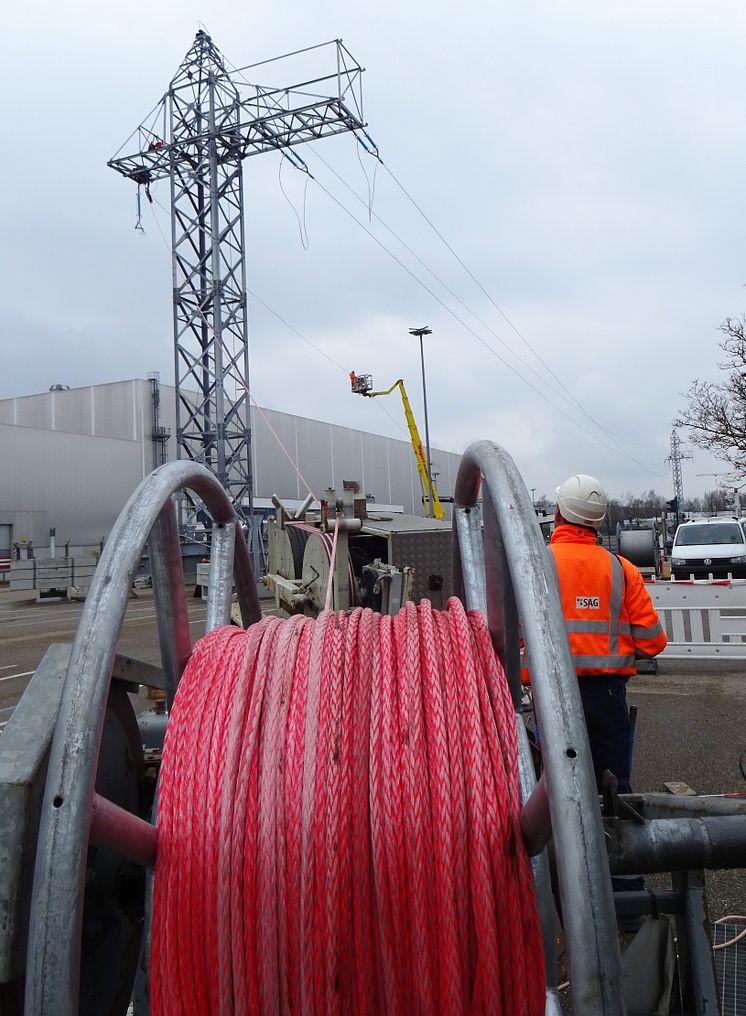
[674,315,746,480]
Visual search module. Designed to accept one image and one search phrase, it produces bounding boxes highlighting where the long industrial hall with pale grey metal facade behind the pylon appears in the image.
[0,378,460,558]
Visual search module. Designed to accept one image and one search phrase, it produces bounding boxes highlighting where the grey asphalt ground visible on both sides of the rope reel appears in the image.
[0,589,746,919]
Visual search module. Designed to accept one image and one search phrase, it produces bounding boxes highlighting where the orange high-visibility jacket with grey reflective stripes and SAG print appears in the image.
[550,523,666,677]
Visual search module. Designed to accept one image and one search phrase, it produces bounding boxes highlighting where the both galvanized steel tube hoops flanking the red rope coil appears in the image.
[26,453,623,1016]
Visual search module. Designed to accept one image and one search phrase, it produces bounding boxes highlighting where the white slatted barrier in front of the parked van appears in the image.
[646,579,746,659]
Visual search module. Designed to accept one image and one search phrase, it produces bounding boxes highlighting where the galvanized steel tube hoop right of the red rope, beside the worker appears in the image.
[453,441,625,1016]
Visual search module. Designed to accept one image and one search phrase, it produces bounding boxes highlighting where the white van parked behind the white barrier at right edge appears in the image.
[671,516,746,579]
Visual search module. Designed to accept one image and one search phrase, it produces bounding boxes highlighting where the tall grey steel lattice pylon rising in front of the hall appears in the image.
[108,31,365,540]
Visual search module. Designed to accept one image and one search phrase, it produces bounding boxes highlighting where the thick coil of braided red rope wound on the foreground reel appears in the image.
[150,599,545,1016]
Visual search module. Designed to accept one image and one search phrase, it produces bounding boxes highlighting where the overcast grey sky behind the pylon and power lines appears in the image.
[0,0,746,497]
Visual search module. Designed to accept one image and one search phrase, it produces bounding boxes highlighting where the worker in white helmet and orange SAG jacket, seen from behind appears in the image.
[550,472,666,793]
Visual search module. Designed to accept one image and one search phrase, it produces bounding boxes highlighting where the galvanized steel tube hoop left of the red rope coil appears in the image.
[25,461,261,1016]
